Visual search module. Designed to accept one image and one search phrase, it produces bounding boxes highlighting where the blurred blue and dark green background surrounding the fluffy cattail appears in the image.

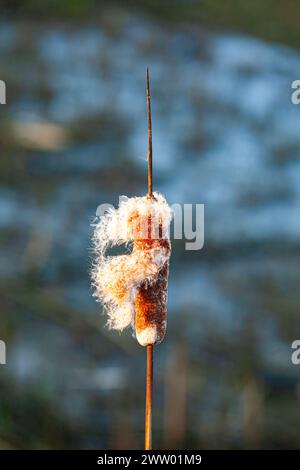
[0,0,300,449]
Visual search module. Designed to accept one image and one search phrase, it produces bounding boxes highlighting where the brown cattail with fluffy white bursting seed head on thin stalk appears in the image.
[92,67,172,450]
